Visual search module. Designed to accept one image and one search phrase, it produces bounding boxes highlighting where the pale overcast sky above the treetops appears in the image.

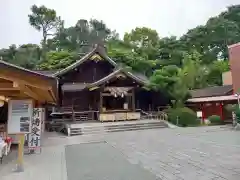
[0,0,240,48]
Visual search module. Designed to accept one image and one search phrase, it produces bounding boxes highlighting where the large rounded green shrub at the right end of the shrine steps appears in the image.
[167,107,200,127]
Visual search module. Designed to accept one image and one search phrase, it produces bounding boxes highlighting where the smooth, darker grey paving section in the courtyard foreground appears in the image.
[66,142,161,180]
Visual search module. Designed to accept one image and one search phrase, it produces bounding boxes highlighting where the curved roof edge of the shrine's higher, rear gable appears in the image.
[53,45,117,76]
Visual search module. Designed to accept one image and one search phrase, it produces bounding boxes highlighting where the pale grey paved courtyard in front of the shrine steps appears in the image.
[0,127,240,180]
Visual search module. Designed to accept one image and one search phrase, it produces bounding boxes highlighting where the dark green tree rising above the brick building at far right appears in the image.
[180,5,240,64]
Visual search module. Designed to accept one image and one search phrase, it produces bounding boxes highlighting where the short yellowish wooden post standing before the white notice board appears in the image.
[15,134,25,172]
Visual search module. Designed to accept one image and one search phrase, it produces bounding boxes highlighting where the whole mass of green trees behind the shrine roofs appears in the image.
[0,5,240,107]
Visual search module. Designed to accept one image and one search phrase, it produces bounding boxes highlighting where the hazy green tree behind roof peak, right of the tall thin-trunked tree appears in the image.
[47,19,113,54]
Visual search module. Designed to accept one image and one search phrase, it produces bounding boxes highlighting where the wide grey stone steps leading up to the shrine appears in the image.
[65,120,168,136]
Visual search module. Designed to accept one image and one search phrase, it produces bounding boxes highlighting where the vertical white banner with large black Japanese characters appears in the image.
[28,108,43,152]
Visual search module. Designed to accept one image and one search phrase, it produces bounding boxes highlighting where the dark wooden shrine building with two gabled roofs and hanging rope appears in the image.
[54,45,168,121]
